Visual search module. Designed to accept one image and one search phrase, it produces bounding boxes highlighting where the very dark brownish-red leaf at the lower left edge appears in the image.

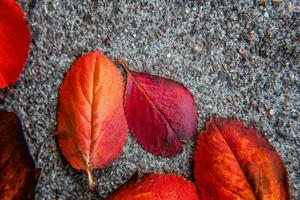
[0,110,40,200]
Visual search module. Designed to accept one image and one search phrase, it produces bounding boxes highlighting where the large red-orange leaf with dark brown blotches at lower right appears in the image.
[194,118,290,200]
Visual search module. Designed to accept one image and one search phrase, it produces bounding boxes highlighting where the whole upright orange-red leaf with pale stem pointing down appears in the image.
[57,51,128,190]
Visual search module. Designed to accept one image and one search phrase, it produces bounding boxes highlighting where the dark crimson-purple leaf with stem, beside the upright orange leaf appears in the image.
[117,59,197,157]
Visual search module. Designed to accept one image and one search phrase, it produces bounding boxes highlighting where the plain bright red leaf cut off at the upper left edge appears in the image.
[0,0,31,89]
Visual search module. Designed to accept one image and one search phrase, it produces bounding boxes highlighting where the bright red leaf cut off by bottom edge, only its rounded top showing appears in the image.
[107,173,199,200]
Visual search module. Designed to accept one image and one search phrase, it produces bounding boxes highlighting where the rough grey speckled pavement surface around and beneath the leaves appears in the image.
[0,0,300,199]
